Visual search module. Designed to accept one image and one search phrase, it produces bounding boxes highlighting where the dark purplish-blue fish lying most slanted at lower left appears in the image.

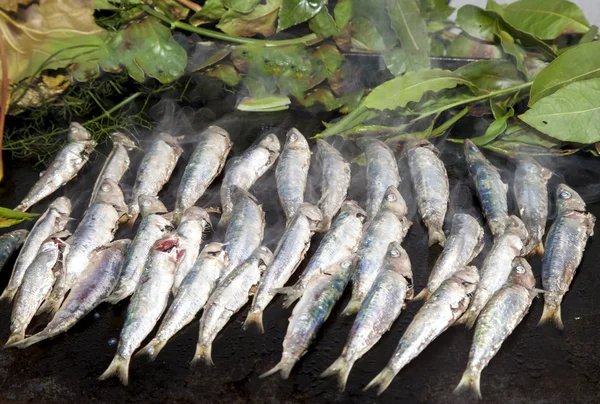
[13,239,131,348]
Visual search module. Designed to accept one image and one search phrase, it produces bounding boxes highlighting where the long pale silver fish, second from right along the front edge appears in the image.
[365,267,479,395]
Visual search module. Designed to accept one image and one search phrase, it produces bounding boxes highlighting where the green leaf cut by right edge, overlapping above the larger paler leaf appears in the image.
[529,42,600,106]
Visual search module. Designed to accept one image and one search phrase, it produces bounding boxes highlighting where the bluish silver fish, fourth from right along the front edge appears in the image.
[260,257,354,379]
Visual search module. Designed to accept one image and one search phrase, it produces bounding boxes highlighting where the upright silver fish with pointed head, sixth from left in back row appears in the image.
[275,128,311,221]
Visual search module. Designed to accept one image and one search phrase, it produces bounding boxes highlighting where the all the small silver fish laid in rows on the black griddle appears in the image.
[0,124,595,394]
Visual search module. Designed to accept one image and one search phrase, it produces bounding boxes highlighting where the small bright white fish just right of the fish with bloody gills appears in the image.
[173,206,211,296]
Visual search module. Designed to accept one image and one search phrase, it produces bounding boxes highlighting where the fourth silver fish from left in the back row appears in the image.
[173,126,233,225]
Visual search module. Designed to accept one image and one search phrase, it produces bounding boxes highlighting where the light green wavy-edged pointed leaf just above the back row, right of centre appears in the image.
[364,69,473,110]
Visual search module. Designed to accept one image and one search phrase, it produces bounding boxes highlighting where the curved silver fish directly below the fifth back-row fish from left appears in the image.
[222,185,265,277]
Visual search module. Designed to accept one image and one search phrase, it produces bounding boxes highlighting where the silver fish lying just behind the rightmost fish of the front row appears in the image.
[459,216,527,328]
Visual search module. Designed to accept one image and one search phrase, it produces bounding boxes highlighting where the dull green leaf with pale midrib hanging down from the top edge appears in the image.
[386,0,429,54]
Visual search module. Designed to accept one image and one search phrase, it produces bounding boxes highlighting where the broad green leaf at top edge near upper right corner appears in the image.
[494,0,589,40]
